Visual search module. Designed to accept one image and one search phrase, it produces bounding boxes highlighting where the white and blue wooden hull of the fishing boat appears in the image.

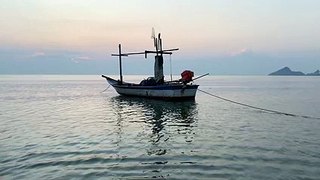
[104,76,198,100]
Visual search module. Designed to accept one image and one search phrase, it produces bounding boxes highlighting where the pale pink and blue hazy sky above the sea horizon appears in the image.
[0,0,320,75]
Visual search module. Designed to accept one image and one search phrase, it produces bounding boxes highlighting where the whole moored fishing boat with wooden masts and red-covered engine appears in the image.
[102,30,208,101]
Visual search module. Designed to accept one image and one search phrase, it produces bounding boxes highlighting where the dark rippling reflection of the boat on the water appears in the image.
[111,96,197,158]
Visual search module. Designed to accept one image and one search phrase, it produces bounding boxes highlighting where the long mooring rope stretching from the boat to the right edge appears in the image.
[198,89,320,119]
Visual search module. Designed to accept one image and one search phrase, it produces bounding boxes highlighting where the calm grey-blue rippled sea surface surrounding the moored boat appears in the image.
[0,76,320,179]
